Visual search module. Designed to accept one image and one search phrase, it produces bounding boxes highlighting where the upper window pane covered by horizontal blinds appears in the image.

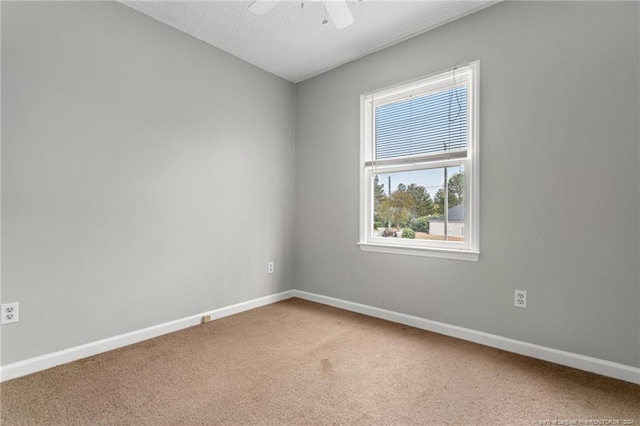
[375,86,467,160]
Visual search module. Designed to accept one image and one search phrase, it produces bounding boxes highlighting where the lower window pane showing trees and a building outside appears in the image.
[372,165,465,242]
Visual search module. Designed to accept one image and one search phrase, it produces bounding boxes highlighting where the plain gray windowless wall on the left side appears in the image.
[2,2,295,364]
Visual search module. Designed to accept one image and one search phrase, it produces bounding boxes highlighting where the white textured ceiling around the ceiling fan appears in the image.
[121,0,498,83]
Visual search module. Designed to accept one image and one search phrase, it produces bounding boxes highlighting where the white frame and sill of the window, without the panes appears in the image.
[358,61,480,262]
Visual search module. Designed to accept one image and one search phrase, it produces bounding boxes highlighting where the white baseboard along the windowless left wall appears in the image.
[0,290,293,382]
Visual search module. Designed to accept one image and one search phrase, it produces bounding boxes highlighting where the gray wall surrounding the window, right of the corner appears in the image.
[295,2,640,366]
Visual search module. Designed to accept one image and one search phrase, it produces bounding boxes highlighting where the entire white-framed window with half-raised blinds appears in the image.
[359,61,479,261]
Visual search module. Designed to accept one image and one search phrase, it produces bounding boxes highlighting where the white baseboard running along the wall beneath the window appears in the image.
[293,290,640,384]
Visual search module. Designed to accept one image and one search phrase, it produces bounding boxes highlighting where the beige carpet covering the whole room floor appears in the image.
[0,299,640,426]
